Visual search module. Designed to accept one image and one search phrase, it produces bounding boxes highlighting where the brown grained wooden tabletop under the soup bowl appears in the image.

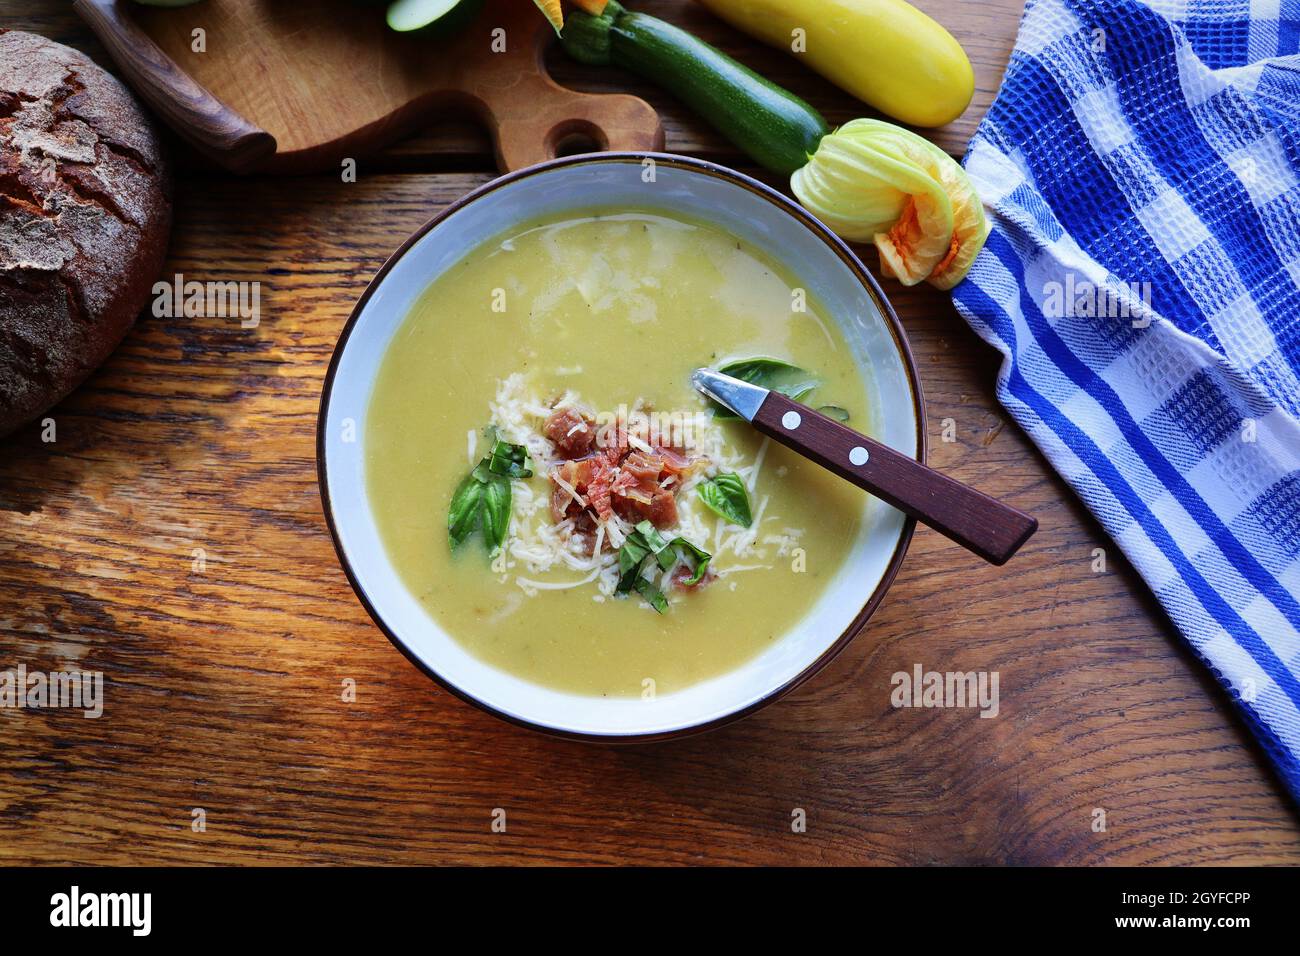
[0,0,1300,864]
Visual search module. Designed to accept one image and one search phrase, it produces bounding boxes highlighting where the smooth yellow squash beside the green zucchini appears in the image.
[699,0,975,126]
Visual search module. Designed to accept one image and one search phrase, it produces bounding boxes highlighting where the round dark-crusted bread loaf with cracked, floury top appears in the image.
[0,30,172,436]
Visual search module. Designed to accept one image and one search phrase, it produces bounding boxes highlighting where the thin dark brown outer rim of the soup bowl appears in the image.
[316,152,926,744]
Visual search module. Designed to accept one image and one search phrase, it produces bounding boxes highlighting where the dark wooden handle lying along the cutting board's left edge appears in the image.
[73,0,276,173]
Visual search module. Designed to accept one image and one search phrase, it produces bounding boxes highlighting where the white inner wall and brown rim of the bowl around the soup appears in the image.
[317,153,924,740]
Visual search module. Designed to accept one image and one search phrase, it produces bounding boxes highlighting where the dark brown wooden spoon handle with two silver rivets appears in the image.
[754,392,1039,564]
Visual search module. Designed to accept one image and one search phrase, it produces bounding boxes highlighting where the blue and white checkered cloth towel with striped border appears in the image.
[953,0,1300,800]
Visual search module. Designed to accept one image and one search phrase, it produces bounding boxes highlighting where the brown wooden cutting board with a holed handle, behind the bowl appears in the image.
[74,0,663,173]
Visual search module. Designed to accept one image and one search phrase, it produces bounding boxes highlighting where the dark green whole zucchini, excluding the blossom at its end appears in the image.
[560,0,829,176]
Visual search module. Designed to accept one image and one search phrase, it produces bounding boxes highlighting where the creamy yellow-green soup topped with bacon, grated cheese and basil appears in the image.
[365,211,872,697]
